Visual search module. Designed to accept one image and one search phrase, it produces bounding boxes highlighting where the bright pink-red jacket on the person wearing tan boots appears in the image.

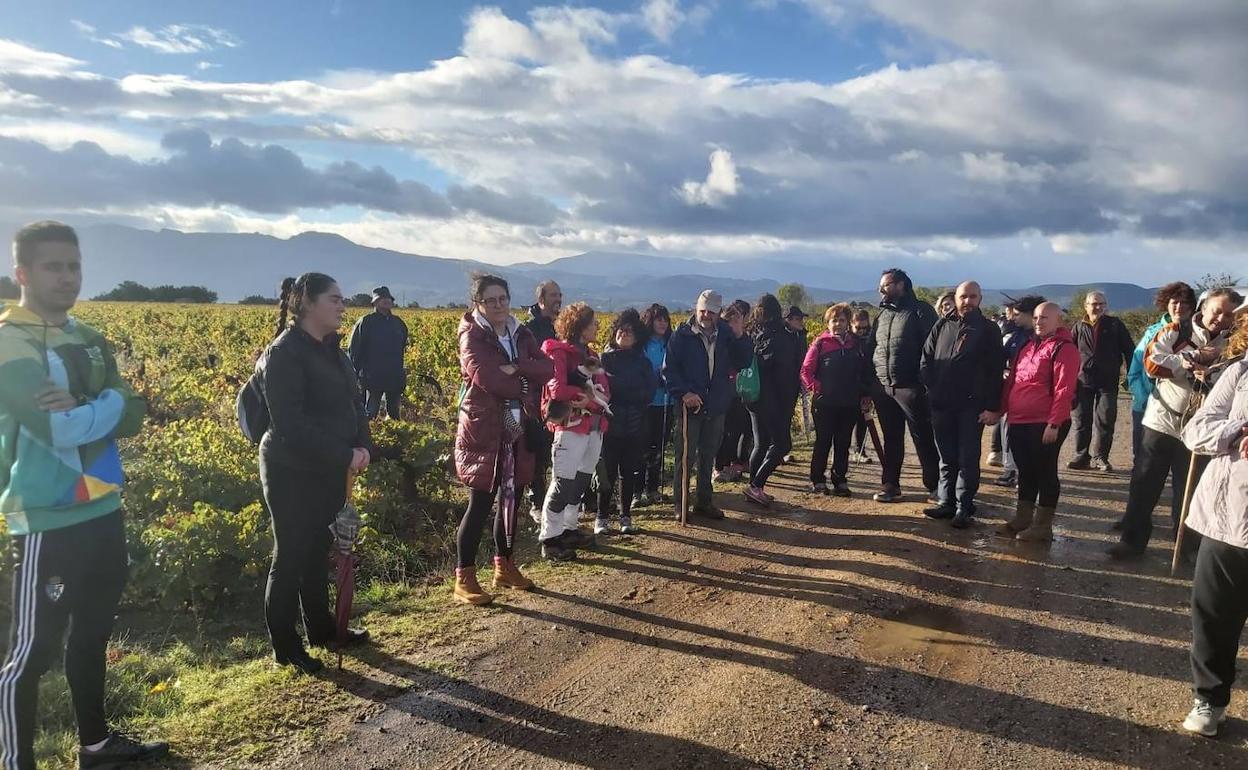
[1001,327,1081,426]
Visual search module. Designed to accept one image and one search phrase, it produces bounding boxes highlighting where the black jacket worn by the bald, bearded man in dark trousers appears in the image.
[921,309,1006,412]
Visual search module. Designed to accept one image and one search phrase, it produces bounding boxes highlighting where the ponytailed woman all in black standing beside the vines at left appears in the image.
[260,273,373,674]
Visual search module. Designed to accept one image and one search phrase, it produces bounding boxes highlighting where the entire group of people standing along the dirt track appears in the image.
[0,222,1248,770]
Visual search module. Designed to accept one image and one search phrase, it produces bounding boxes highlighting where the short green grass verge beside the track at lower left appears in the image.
[36,584,473,770]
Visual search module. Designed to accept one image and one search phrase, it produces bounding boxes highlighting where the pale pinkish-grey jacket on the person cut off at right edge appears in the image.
[1183,361,1248,548]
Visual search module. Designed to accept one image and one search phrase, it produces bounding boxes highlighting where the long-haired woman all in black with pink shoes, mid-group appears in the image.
[745,295,805,505]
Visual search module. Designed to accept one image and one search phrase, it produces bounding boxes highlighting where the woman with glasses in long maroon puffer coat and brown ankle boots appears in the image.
[454,276,554,604]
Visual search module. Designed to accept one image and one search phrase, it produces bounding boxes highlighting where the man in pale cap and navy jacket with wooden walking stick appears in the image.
[663,290,754,522]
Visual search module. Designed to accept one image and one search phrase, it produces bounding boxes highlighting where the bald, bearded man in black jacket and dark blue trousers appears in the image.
[919,281,1006,529]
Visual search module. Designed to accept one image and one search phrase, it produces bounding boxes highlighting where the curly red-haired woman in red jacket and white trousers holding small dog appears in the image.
[538,302,610,562]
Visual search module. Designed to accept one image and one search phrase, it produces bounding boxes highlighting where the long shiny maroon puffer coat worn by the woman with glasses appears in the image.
[456,312,553,492]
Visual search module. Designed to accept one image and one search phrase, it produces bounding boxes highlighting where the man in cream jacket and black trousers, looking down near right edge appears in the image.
[1106,288,1243,559]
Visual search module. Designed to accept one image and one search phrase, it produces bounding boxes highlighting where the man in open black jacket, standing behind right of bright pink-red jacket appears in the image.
[1066,291,1136,473]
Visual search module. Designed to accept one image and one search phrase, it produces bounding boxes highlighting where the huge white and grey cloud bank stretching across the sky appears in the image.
[0,0,1248,280]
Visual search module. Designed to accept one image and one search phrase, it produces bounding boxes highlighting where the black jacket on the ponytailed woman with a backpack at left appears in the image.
[260,326,366,469]
